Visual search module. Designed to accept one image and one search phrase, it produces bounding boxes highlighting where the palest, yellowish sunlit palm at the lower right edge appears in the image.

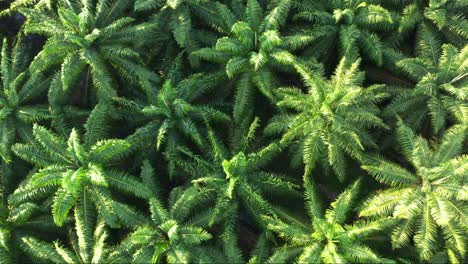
[360,120,468,263]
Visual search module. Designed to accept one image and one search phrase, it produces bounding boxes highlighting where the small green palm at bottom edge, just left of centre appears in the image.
[114,161,211,263]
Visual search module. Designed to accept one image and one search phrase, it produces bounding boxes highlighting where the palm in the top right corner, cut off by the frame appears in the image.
[398,0,468,48]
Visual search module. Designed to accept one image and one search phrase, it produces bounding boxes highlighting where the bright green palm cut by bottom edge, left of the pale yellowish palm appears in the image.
[266,177,390,263]
